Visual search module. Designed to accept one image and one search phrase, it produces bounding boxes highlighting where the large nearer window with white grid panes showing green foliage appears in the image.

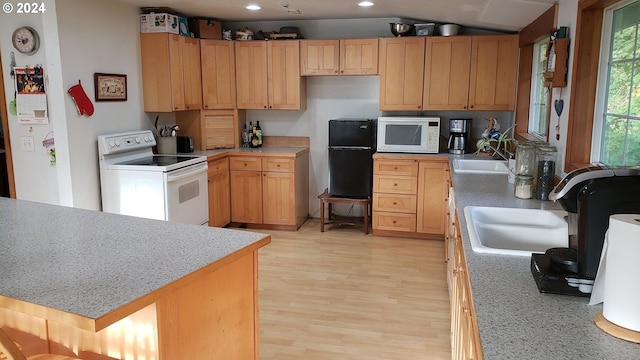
[591,1,640,166]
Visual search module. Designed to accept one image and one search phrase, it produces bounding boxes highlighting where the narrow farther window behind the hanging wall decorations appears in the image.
[528,38,549,140]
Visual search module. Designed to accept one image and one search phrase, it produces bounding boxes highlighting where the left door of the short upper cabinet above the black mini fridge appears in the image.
[300,40,340,76]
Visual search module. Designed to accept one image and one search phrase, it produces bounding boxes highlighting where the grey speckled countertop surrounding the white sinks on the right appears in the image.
[451,155,640,360]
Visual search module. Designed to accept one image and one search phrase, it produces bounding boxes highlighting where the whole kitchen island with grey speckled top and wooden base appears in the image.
[0,198,271,360]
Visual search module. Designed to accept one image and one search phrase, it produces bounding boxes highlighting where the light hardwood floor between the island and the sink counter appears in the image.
[257,219,451,360]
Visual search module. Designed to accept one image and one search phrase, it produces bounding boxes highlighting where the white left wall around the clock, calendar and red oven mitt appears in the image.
[0,0,152,210]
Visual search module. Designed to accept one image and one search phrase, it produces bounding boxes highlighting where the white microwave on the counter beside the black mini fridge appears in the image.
[377,116,440,154]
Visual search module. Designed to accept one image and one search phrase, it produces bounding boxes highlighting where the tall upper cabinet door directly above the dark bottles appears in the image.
[235,41,268,109]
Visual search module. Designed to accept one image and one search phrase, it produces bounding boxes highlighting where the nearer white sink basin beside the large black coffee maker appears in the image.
[464,206,569,256]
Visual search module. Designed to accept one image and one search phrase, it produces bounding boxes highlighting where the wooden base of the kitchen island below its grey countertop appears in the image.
[0,249,259,360]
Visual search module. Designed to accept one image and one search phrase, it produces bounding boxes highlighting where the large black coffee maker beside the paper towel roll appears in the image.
[531,165,640,296]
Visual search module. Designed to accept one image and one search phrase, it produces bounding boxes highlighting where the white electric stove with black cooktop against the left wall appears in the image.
[98,130,209,225]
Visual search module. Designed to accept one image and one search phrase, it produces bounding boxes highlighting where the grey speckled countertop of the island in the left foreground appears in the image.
[0,198,270,330]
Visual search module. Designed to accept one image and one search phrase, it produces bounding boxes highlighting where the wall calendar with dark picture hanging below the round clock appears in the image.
[14,66,49,124]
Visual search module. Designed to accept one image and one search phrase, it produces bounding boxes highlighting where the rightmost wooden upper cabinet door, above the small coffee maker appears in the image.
[469,35,518,111]
